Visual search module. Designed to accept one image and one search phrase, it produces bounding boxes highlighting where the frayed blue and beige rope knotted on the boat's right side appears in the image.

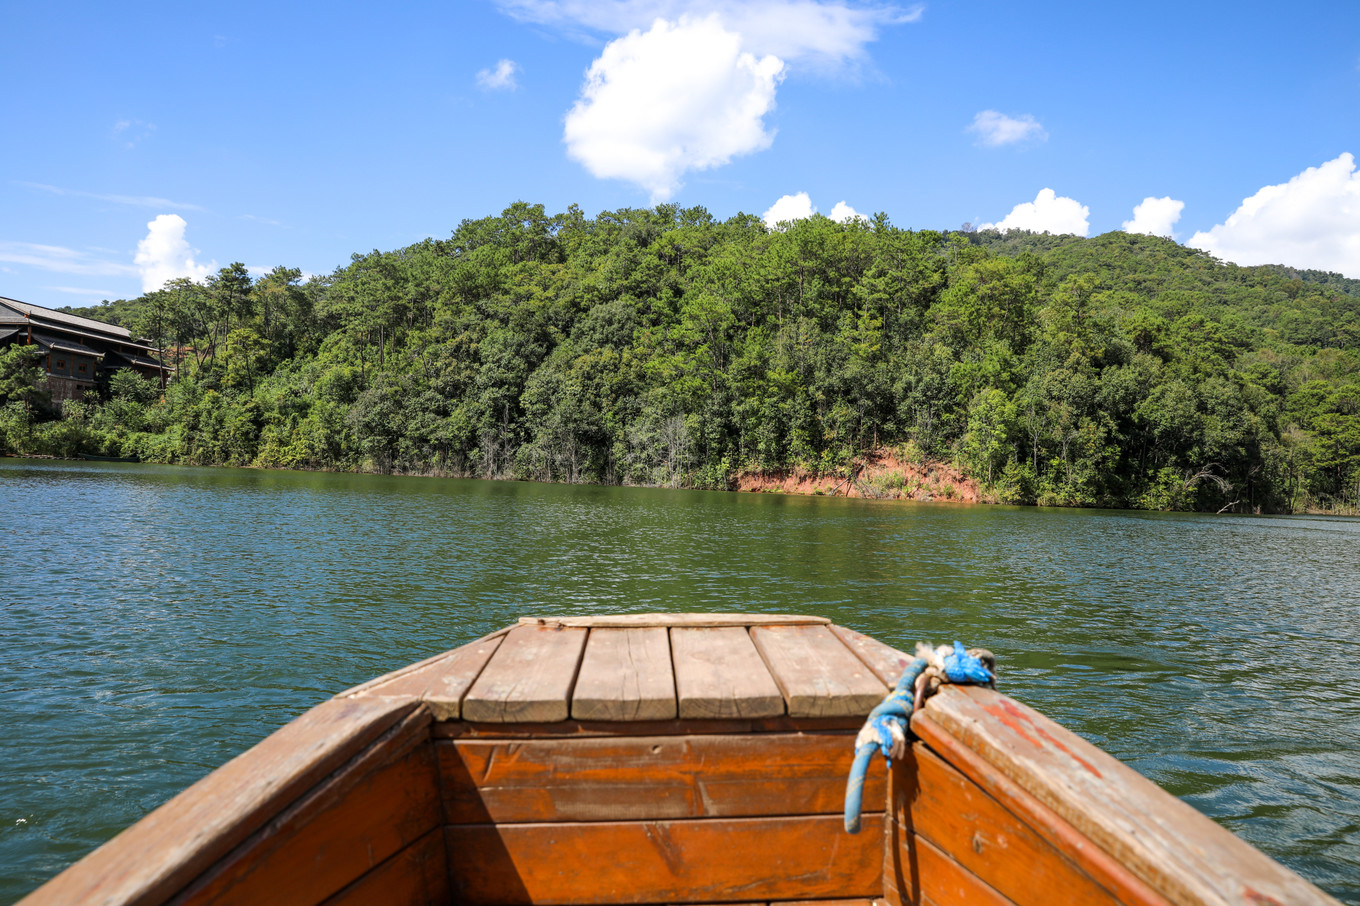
[846,642,997,834]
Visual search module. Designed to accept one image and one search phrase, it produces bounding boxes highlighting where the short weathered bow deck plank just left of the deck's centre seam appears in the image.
[571,626,677,721]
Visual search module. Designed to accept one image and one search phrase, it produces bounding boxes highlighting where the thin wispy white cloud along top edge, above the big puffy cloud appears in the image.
[496,0,925,67]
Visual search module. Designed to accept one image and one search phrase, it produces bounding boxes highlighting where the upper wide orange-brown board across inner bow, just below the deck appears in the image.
[437,732,887,824]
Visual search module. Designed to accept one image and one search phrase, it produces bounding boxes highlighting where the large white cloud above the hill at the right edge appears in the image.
[1186,152,1360,278]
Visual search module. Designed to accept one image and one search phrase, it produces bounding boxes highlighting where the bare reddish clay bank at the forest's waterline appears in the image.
[733,450,982,503]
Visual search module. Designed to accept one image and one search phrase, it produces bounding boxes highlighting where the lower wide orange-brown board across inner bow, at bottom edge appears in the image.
[446,813,883,906]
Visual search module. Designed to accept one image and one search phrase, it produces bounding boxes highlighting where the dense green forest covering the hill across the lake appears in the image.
[0,203,1360,511]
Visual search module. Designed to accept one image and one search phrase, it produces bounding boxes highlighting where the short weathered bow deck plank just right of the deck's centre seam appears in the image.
[670,626,785,720]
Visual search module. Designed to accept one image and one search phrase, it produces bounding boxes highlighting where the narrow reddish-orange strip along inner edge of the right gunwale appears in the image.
[911,713,1171,906]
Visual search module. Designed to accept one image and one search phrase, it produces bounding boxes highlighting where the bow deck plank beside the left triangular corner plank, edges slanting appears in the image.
[462,626,588,724]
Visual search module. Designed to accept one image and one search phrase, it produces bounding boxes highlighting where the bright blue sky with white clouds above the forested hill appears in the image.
[0,0,1360,306]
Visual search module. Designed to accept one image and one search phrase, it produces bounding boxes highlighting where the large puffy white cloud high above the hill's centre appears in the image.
[563,16,783,203]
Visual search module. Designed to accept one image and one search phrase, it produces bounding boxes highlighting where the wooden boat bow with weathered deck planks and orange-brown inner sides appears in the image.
[23,614,1336,906]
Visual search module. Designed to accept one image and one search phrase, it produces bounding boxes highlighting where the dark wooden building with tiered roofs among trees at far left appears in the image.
[0,297,173,403]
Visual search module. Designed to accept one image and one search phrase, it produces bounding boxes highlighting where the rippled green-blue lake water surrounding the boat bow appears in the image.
[0,460,1360,903]
